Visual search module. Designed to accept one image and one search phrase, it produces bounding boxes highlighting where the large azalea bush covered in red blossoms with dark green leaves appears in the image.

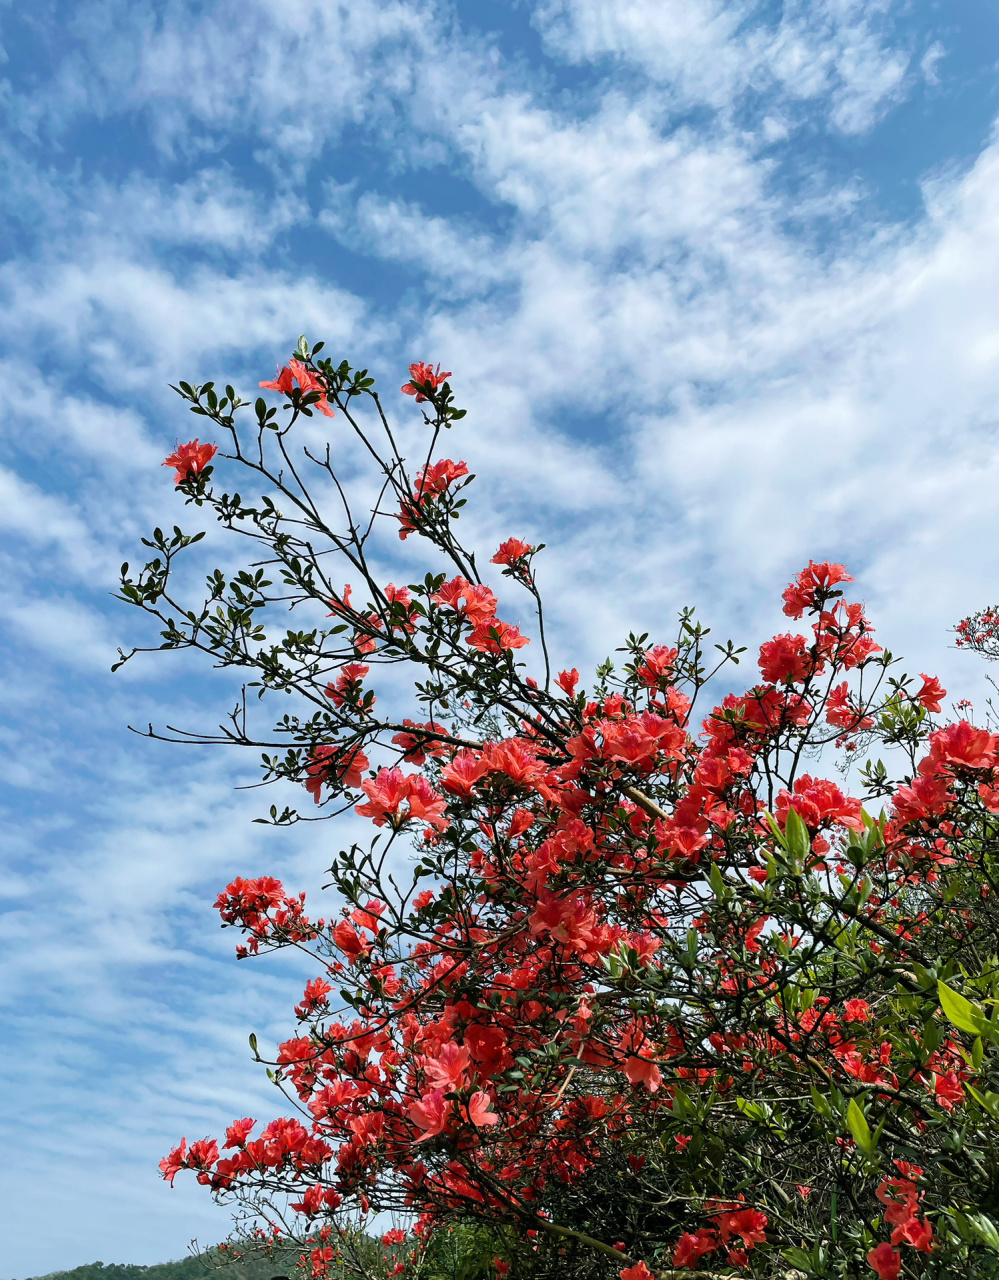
[120,339,999,1280]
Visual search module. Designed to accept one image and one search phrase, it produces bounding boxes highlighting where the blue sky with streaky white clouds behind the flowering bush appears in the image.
[0,0,999,1280]
